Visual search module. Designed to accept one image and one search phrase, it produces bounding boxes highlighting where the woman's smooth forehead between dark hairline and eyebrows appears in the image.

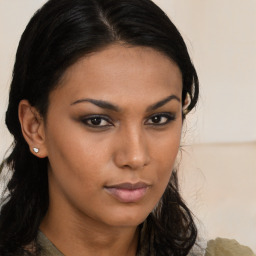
[50,45,182,107]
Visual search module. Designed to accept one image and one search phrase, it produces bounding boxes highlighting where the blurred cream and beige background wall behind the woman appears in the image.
[0,0,256,251]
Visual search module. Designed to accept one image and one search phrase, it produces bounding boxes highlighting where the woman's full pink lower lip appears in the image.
[105,187,148,203]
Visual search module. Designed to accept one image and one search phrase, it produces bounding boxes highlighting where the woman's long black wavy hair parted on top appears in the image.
[0,0,198,256]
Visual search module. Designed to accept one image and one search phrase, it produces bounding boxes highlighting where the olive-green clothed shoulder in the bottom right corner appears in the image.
[205,238,256,256]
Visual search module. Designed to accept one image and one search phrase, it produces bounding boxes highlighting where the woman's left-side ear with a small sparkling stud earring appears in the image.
[18,100,48,158]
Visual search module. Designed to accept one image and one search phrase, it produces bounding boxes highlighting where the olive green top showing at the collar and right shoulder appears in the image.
[38,231,256,256]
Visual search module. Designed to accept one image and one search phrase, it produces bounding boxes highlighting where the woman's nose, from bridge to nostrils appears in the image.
[114,128,150,170]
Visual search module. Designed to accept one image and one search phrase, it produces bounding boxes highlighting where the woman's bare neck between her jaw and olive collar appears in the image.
[40,200,139,256]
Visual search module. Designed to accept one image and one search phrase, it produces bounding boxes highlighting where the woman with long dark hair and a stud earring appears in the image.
[0,0,246,256]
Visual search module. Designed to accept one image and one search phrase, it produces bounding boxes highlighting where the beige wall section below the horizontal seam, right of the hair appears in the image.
[179,142,256,252]
